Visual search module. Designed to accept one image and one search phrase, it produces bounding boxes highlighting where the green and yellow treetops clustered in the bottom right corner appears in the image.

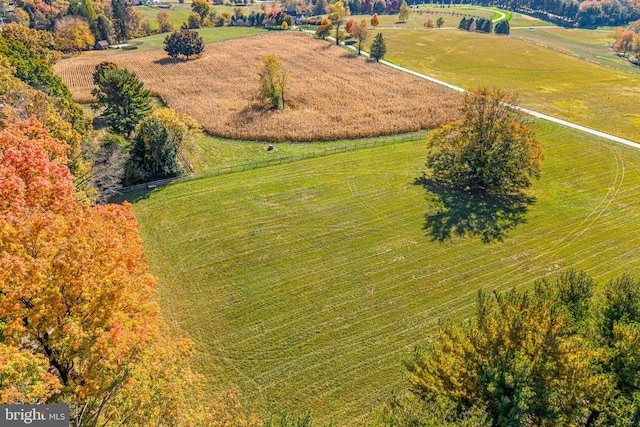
[400,271,640,427]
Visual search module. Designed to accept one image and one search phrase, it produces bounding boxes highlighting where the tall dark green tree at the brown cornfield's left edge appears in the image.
[91,62,152,137]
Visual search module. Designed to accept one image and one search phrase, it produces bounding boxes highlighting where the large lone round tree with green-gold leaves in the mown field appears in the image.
[427,88,543,194]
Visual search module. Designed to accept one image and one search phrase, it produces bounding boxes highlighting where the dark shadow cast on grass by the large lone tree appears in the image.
[414,176,535,243]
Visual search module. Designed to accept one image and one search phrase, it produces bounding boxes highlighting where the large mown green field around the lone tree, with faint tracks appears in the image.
[134,122,640,426]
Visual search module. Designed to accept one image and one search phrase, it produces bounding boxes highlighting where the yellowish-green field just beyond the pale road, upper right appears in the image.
[370,30,640,144]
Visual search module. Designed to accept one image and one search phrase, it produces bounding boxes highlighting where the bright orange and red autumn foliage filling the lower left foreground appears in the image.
[0,119,208,426]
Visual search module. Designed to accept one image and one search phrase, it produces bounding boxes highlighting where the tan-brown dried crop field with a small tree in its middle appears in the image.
[55,32,461,141]
